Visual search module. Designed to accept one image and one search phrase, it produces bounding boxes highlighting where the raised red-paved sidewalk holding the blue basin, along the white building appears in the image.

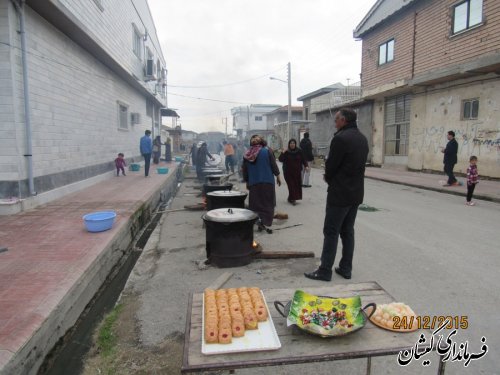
[0,163,184,374]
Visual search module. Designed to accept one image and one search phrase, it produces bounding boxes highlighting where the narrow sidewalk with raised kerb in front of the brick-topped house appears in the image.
[365,167,500,203]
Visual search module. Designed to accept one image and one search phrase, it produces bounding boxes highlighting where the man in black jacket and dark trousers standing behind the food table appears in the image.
[304,108,368,281]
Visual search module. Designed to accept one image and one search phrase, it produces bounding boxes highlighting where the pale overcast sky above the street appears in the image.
[148,0,376,133]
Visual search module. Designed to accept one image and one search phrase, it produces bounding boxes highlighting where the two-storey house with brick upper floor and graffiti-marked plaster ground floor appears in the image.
[354,0,500,178]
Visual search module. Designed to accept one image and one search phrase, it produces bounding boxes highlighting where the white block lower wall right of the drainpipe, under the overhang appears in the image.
[17,8,151,176]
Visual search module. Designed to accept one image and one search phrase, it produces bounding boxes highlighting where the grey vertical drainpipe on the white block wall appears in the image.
[12,0,36,195]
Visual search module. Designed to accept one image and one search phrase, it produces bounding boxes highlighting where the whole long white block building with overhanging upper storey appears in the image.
[0,0,166,211]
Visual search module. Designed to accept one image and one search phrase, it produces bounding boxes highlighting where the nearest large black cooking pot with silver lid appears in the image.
[202,208,257,268]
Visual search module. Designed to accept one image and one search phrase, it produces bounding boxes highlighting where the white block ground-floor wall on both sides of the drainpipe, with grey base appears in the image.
[0,0,157,198]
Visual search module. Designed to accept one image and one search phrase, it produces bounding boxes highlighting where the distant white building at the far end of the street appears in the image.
[231,104,281,139]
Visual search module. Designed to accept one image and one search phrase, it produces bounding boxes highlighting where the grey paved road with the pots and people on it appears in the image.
[119,170,500,374]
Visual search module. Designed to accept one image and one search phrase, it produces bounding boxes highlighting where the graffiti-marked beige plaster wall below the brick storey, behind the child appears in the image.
[408,78,500,178]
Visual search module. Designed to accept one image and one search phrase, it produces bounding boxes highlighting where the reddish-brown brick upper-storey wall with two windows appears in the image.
[361,0,500,90]
